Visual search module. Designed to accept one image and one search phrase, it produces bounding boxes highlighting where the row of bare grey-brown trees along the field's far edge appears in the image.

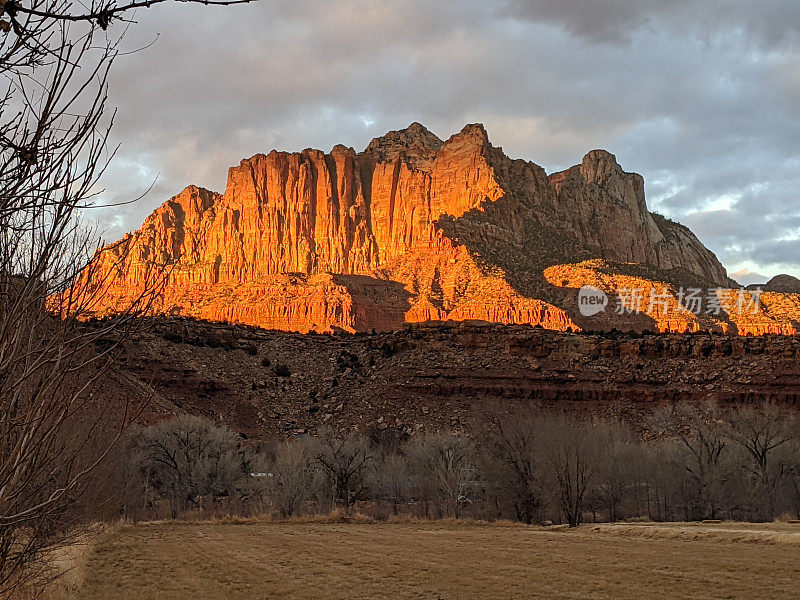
[110,404,800,525]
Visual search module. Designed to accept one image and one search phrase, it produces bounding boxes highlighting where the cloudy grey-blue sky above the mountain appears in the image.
[94,0,800,283]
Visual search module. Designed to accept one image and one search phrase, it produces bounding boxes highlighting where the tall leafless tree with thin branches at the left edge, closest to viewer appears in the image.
[0,0,250,595]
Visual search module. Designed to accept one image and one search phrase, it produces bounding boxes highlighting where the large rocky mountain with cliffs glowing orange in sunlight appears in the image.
[76,123,800,333]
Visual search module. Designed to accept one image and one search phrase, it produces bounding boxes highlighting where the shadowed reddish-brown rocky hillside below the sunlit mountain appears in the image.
[119,319,800,439]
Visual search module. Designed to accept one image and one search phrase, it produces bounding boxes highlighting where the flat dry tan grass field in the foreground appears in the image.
[70,522,800,600]
